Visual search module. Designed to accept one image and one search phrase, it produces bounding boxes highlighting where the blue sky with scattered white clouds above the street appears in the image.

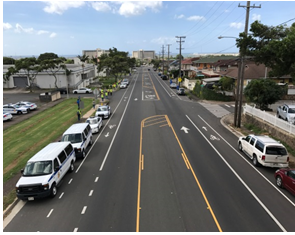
[2,1,295,57]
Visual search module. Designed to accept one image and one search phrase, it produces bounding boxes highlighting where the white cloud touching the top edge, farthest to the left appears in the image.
[43,1,85,15]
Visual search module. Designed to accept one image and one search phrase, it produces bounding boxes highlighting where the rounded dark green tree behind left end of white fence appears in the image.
[244,79,285,110]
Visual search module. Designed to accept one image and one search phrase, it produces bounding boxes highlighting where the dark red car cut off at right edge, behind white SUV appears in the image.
[275,168,295,195]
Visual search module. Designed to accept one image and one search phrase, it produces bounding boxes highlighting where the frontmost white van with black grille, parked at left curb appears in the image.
[16,142,76,200]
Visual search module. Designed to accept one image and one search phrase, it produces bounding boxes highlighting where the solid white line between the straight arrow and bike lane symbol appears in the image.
[185,115,287,232]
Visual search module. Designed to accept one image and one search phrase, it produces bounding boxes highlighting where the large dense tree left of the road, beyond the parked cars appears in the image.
[98,47,133,81]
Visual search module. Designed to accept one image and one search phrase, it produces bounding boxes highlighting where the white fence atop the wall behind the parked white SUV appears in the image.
[244,104,295,135]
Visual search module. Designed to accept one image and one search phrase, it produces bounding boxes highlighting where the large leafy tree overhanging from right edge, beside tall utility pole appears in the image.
[237,21,295,78]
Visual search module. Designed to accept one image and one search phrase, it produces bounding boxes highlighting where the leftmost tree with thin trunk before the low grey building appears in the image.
[5,57,43,92]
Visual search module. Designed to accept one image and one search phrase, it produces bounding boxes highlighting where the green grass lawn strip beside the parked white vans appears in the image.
[3,98,92,183]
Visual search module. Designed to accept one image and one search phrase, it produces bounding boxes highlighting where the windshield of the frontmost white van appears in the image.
[23,161,53,176]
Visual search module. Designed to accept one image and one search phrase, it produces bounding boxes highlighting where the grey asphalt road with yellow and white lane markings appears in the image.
[4,68,295,232]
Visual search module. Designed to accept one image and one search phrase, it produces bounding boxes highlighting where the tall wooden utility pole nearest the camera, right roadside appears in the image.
[234,1,261,127]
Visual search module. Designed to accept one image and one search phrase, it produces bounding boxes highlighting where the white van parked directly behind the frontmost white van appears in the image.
[61,123,93,158]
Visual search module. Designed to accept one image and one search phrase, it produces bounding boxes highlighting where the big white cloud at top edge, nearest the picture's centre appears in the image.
[118,1,162,17]
